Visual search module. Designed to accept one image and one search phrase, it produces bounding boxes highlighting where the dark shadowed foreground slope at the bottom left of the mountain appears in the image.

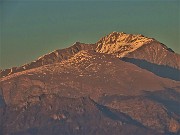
[0,95,161,135]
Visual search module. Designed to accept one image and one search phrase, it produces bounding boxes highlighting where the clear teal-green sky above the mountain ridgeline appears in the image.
[0,0,180,69]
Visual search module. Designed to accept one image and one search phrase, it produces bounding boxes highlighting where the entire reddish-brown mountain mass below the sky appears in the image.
[0,32,180,135]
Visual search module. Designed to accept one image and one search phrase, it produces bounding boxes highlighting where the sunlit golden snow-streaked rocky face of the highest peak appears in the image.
[96,31,156,57]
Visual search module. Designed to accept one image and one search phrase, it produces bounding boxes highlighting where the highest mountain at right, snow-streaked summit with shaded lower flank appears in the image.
[96,32,180,81]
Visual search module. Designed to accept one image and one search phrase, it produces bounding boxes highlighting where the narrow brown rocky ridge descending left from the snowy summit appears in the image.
[0,42,96,77]
